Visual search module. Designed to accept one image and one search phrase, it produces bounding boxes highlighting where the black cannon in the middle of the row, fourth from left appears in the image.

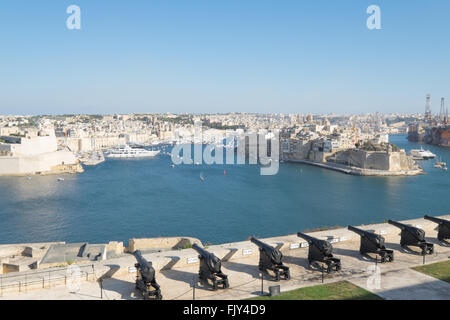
[297,232,341,273]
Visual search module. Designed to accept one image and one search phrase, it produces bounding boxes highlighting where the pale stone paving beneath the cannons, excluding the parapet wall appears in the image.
[0,231,450,300]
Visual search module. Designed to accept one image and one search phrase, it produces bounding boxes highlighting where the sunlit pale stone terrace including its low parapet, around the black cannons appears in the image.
[0,215,450,300]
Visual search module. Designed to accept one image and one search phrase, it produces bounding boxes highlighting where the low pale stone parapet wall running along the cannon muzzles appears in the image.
[3,215,450,294]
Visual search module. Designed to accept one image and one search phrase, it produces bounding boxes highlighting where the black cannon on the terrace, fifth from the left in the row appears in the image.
[348,226,394,263]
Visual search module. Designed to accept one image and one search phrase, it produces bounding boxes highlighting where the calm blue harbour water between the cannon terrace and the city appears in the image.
[0,135,450,244]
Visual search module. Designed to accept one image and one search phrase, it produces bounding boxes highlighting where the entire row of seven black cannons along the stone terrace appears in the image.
[134,215,450,300]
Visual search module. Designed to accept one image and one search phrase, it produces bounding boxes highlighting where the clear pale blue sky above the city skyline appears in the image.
[0,0,450,114]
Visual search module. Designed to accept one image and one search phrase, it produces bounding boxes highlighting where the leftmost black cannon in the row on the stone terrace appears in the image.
[133,250,162,300]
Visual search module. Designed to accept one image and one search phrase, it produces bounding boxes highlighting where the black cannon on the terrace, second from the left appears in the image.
[192,243,230,290]
